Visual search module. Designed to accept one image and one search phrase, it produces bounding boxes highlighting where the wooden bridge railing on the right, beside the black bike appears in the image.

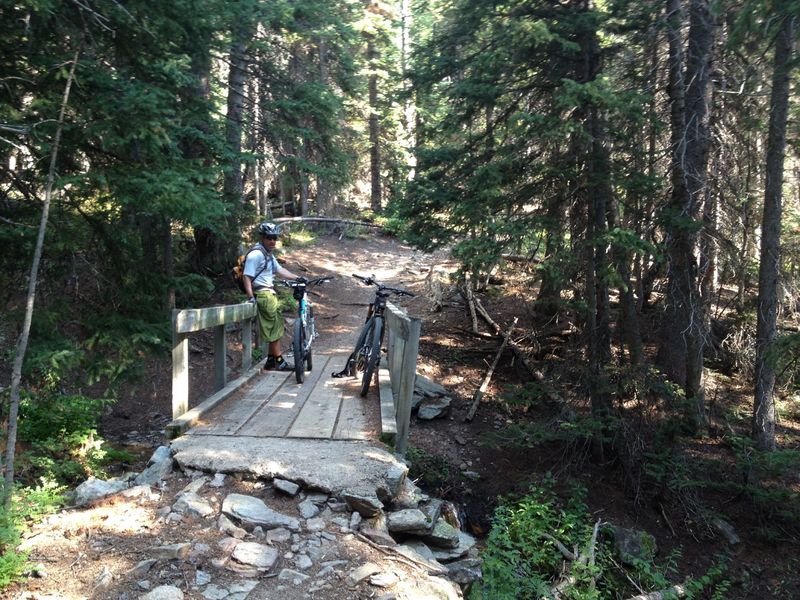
[379,302,421,455]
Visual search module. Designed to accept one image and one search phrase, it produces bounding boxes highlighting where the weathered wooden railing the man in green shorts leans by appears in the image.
[172,302,256,419]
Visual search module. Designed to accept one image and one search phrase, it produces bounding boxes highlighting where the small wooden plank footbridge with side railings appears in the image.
[167,304,419,453]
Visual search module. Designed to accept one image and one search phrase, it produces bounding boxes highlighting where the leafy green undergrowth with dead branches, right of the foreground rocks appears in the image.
[470,477,731,600]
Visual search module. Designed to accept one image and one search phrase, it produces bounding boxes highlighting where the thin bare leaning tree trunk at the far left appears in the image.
[3,47,81,508]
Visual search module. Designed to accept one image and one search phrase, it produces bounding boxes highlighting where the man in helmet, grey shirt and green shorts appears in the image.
[242,221,298,371]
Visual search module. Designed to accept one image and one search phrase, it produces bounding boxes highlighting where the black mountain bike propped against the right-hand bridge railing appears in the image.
[332,274,414,397]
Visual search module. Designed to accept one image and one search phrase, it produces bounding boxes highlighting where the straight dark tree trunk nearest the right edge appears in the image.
[752,15,794,450]
